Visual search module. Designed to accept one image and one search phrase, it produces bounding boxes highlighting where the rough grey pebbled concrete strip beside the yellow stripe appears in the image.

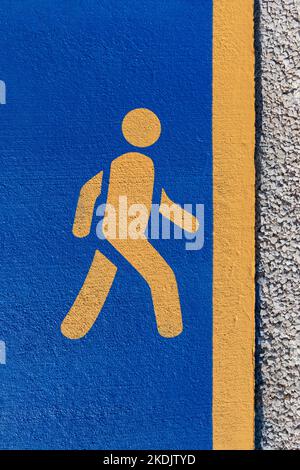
[255,0,300,449]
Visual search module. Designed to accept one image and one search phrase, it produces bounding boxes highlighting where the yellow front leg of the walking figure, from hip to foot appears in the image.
[110,239,183,338]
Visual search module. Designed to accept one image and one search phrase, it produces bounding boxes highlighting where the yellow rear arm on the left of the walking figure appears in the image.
[72,171,103,238]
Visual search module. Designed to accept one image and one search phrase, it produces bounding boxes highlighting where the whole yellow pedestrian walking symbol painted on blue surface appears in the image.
[61,108,199,339]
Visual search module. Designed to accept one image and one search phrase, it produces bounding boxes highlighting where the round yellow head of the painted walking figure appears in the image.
[122,108,161,147]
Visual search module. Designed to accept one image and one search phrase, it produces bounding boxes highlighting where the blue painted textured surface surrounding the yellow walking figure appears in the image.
[0,0,212,449]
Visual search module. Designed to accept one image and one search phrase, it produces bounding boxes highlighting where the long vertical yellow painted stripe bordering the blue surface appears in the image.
[213,0,255,449]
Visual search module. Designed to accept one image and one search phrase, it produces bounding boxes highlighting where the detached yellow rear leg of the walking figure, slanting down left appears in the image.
[61,251,117,339]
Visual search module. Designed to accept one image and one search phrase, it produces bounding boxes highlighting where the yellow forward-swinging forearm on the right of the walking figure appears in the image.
[159,189,199,233]
